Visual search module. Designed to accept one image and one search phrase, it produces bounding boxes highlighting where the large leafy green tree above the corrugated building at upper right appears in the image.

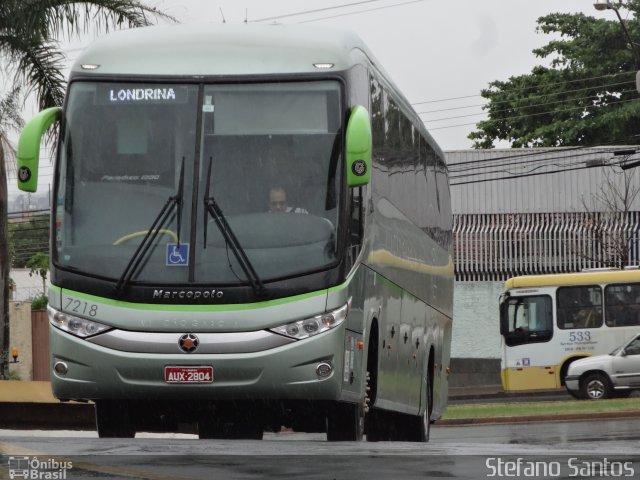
[469,0,640,148]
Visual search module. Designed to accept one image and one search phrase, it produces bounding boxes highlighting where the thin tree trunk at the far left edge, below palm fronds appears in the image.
[0,141,10,380]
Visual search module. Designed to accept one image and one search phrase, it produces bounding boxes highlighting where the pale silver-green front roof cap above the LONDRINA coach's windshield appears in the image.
[72,23,373,76]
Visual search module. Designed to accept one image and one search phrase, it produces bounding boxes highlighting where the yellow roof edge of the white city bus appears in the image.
[504,268,640,290]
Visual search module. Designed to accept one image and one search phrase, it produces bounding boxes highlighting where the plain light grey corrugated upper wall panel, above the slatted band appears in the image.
[445,147,640,214]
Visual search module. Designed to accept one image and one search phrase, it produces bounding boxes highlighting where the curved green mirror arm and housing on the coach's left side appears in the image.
[17,107,62,192]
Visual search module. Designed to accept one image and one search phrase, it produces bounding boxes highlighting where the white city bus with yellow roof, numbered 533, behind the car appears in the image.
[500,269,640,391]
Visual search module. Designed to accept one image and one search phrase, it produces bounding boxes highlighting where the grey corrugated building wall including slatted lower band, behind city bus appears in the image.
[446,148,640,281]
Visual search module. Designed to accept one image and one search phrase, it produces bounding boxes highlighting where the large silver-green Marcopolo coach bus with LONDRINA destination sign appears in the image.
[18,24,453,441]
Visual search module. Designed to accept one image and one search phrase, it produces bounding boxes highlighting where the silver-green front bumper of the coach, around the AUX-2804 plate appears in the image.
[49,325,345,401]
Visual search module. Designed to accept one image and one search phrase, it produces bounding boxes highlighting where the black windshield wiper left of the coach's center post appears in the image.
[116,157,184,296]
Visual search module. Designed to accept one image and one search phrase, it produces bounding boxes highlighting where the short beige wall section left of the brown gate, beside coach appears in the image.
[9,301,33,380]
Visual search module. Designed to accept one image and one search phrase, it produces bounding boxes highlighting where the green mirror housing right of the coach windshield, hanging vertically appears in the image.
[346,105,372,187]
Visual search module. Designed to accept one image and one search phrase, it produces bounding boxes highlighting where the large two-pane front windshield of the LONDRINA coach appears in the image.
[53,80,342,284]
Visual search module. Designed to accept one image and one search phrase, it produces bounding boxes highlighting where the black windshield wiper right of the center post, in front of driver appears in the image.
[204,157,267,297]
